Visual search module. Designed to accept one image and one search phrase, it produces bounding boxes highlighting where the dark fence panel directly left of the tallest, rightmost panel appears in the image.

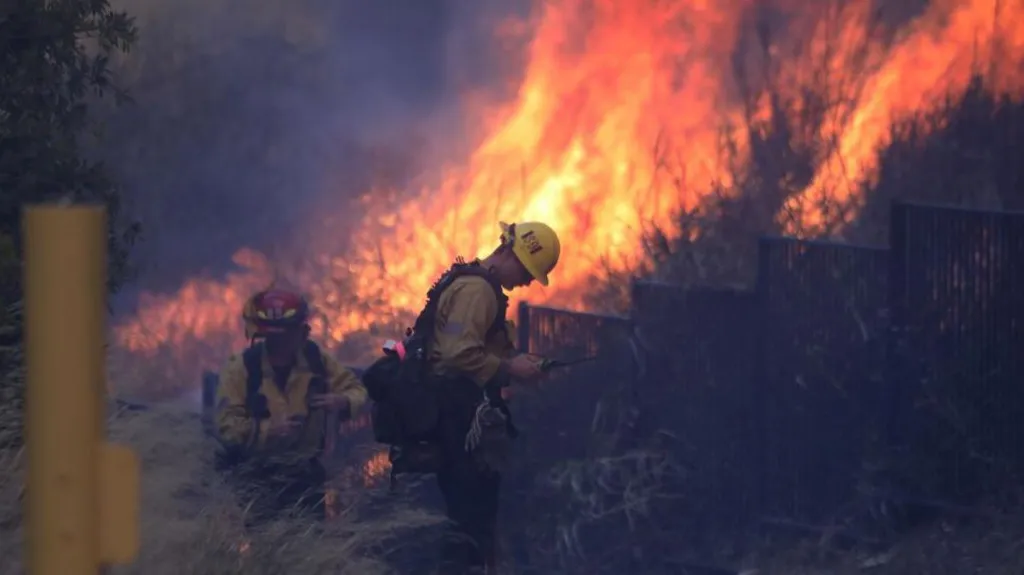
[757,237,889,522]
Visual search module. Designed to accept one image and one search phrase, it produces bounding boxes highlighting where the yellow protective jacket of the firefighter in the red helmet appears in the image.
[216,339,367,459]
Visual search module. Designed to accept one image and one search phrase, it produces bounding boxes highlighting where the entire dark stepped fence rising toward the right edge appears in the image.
[512,204,1024,530]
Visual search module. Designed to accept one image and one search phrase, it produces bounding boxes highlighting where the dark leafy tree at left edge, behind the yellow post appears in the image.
[0,0,138,443]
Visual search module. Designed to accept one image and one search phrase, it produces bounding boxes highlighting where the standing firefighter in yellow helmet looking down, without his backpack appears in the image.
[428,222,561,573]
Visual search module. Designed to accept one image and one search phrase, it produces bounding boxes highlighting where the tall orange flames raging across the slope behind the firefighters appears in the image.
[114,0,1024,392]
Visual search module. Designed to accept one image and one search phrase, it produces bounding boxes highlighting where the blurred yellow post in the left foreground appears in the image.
[24,206,138,575]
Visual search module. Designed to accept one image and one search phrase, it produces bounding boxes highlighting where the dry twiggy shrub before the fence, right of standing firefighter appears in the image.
[491,329,686,574]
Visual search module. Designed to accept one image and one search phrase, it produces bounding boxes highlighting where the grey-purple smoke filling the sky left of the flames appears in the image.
[100,0,522,307]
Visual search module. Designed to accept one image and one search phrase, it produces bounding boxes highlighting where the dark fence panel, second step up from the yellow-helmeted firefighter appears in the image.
[632,281,761,546]
